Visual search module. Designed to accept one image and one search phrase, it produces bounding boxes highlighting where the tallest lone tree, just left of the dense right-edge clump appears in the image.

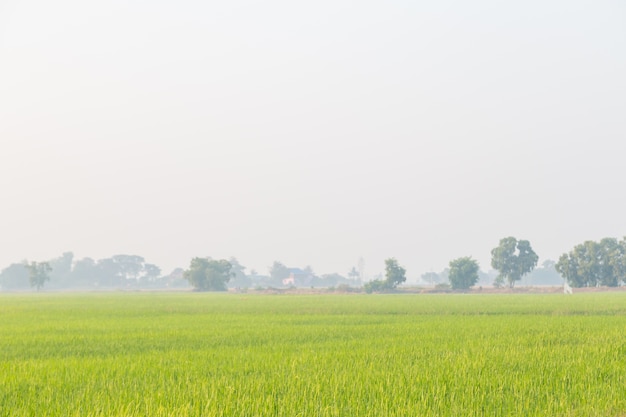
[491,237,539,288]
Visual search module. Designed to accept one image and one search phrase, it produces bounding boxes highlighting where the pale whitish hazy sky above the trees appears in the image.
[0,0,626,279]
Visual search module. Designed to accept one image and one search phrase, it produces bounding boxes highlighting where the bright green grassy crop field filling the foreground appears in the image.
[0,292,626,417]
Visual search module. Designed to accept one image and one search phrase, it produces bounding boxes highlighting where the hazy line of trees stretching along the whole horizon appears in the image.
[0,236,626,293]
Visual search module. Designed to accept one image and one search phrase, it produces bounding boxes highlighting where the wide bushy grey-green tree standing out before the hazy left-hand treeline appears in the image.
[183,258,233,291]
